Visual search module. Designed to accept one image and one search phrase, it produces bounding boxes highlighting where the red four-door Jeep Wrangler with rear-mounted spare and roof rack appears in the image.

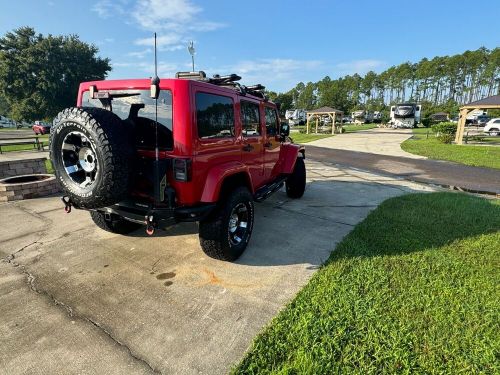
[50,72,306,260]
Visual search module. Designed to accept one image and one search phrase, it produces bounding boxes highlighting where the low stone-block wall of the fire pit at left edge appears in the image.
[0,174,59,202]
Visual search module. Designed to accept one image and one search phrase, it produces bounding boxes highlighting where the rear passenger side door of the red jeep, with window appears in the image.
[240,99,264,188]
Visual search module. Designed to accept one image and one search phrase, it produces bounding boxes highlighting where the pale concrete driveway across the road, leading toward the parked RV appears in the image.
[308,128,427,159]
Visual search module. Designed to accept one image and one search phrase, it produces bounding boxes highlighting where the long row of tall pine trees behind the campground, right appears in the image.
[269,47,500,114]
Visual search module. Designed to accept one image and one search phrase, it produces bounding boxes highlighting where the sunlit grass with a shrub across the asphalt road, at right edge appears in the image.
[401,128,500,169]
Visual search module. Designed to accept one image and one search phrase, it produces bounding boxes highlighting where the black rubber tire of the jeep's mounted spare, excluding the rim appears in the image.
[50,108,134,208]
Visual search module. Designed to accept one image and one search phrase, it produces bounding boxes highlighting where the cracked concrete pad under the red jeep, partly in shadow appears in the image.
[0,162,430,374]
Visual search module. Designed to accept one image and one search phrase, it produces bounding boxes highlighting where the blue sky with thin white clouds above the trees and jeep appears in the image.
[0,0,500,91]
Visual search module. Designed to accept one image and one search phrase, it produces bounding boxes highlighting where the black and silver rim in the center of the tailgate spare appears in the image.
[61,131,99,188]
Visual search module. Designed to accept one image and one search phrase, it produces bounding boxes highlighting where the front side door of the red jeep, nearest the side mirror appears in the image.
[264,105,280,181]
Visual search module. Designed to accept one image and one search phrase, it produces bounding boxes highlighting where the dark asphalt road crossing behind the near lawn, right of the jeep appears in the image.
[306,146,500,195]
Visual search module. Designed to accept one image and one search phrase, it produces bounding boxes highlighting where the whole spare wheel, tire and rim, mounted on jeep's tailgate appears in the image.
[50,108,133,208]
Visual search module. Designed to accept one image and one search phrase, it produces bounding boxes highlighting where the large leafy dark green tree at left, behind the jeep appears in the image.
[0,27,111,121]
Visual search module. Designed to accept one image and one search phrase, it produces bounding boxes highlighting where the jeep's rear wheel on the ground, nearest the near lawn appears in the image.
[199,187,254,261]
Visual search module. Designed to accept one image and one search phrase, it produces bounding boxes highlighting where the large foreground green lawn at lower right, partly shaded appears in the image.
[233,193,500,374]
